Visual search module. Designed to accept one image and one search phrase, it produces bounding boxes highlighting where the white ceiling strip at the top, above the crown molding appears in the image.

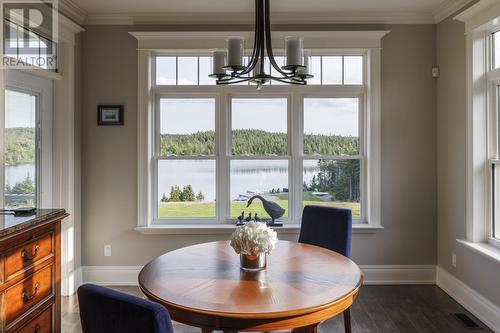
[74,0,445,14]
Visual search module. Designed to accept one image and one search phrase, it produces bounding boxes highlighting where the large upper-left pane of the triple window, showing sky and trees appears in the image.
[160,98,215,156]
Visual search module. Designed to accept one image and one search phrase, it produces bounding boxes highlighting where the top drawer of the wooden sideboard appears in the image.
[4,232,54,280]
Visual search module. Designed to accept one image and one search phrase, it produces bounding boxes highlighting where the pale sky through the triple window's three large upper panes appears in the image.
[160,98,359,136]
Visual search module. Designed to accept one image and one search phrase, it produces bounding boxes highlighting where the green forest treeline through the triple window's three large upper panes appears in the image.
[160,130,359,156]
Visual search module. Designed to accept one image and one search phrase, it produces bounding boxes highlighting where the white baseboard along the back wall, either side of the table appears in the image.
[82,265,436,286]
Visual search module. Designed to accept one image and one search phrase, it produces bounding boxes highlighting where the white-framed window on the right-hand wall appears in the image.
[467,21,500,246]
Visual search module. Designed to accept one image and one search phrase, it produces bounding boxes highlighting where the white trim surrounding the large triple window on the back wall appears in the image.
[130,31,388,233]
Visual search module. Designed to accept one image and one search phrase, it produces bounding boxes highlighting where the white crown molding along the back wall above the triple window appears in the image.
[85,12,435,25]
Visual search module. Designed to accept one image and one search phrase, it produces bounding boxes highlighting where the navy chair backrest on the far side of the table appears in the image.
[299,206,352,257]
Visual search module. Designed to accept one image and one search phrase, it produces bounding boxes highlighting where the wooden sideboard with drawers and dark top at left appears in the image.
[0,209,68,333]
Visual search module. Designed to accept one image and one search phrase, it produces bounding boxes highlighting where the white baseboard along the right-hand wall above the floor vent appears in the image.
[436,267,500,333]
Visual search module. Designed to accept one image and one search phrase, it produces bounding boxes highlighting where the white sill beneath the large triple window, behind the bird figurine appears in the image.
[135,224,384,235]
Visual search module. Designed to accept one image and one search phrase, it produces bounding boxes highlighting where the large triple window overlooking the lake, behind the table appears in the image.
[152,51,366,224]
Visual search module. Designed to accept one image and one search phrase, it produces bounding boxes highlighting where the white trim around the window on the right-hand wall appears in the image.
[455,0,500,258]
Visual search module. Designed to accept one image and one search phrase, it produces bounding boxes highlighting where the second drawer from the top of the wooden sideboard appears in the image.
[4,264,54,325]
